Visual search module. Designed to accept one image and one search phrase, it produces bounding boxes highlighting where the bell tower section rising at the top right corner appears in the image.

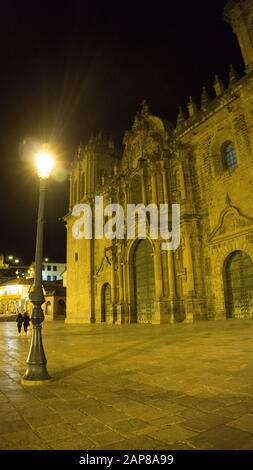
[224,0,253,72]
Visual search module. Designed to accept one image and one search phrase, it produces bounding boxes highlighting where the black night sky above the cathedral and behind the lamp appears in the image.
[0,0,243,263]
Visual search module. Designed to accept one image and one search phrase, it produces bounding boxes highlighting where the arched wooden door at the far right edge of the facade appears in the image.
[224,251,253,318]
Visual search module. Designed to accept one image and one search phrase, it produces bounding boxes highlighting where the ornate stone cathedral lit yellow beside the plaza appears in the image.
[65,0,253,324]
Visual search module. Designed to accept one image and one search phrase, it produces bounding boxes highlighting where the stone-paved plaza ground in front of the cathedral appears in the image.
[0,320,253,450]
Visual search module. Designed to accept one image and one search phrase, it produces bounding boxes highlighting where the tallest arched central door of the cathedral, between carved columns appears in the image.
[133,240,155,323]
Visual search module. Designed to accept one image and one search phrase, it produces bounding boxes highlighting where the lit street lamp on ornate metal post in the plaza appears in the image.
[22,148,54,385]
